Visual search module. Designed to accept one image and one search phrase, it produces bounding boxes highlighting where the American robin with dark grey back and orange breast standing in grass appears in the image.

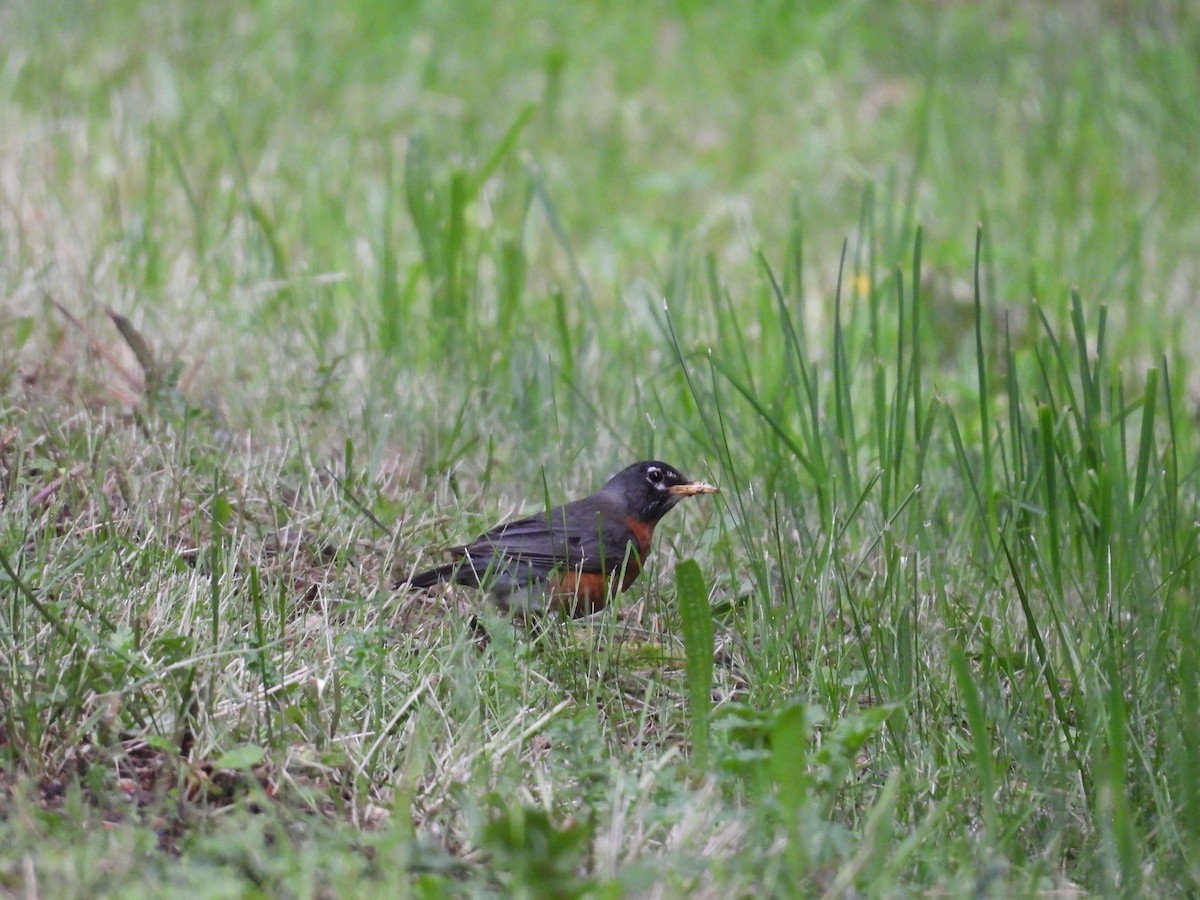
[407,460,716,617]
